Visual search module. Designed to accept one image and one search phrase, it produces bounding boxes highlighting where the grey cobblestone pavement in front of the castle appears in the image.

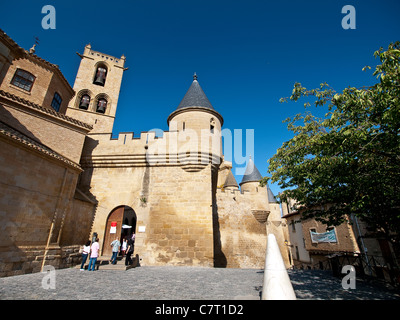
[0,267,400,300]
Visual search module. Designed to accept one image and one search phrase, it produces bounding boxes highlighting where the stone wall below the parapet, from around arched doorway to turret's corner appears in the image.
[79,166,213,266]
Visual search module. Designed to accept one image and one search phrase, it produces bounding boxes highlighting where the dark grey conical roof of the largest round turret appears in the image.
[167,73,224,126]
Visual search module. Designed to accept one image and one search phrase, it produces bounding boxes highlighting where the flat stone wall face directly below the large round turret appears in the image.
[143,165,214,267]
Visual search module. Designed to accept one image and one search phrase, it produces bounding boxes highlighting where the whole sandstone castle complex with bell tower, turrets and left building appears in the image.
[0,30,289,276]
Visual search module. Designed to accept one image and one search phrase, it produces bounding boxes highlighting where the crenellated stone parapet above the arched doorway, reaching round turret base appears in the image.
[81,131,221,172]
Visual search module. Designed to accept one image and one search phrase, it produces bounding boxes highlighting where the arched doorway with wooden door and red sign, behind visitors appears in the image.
[102,206,137,256]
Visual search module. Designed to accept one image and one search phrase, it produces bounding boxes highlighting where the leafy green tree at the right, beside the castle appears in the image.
[262,42,400,243]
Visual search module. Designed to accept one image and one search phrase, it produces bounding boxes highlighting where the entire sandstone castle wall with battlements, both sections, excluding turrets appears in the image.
[81,132,289,268]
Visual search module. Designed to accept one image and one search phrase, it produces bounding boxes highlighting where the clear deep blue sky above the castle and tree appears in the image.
[0,0,400,194]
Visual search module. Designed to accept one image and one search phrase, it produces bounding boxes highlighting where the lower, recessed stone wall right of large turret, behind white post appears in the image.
[216,187,289,268]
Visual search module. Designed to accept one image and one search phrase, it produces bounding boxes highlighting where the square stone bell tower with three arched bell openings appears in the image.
[66,44,127,133]
